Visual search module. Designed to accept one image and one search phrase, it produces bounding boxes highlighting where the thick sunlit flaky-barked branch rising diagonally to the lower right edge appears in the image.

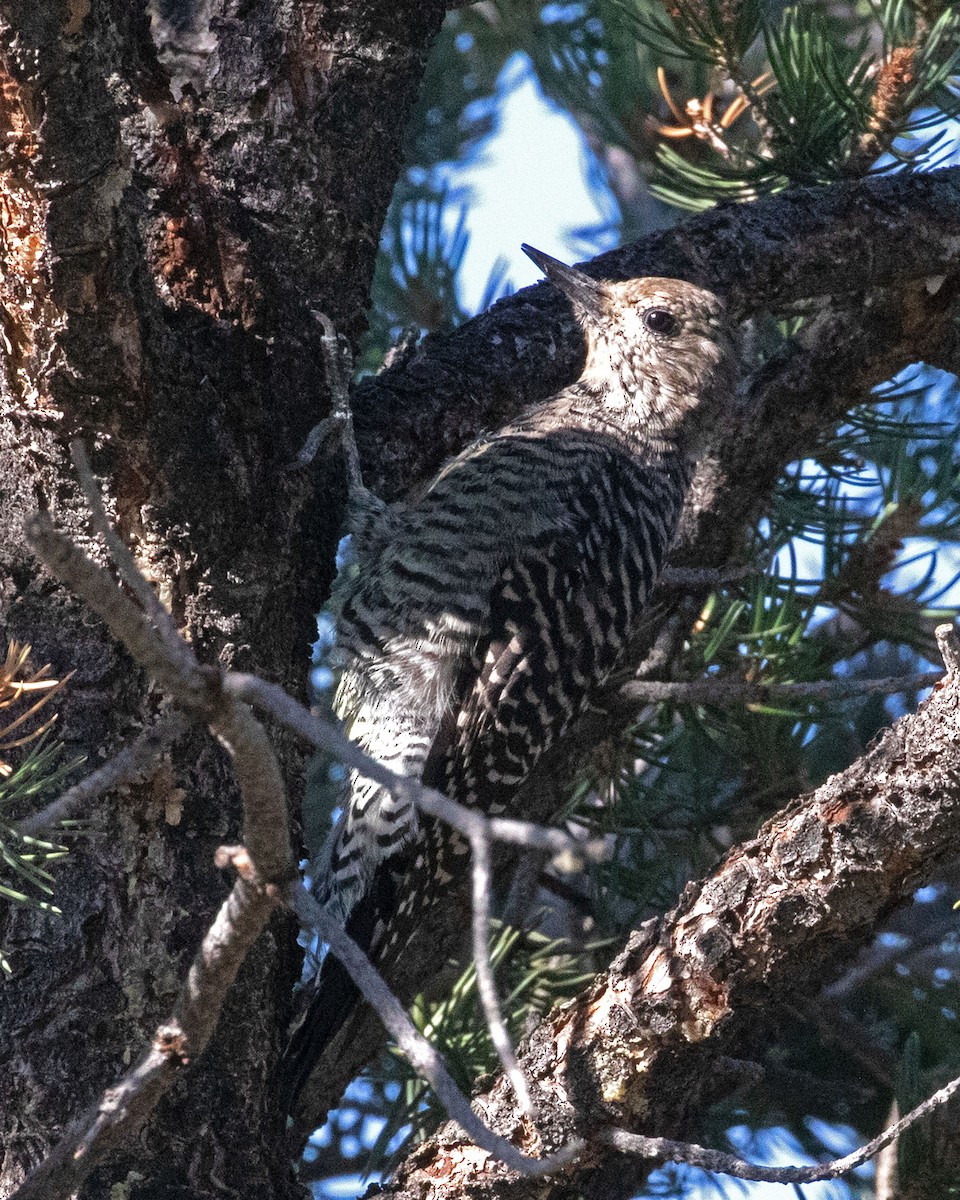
[367,676,960,1200]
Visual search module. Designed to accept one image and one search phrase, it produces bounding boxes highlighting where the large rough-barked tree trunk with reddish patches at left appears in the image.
[0,0,443,1200]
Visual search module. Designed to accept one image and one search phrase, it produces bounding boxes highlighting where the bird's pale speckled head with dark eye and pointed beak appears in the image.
[523,246,739,457]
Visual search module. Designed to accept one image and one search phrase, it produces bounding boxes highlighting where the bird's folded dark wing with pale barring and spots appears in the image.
[424,458,679,812]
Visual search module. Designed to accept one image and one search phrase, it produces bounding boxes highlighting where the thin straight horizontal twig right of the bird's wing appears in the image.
[617,671,943,704]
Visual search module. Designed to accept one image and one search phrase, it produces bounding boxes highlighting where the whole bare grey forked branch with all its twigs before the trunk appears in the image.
[16,513,589,1200]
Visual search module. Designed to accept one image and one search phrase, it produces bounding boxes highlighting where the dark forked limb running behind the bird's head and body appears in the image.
[290,168,960,1138]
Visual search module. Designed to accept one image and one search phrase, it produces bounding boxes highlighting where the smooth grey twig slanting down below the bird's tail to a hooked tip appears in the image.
[284,883,583,1175]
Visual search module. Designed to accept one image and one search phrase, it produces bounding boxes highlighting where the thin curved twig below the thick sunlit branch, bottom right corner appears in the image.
[599,1076,960,1183]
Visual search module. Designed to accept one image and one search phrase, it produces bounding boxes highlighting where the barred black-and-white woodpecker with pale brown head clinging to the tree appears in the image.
[281,245,739,1111]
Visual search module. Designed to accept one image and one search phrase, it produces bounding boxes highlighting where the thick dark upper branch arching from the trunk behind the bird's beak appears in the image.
[353,167,960,499]
